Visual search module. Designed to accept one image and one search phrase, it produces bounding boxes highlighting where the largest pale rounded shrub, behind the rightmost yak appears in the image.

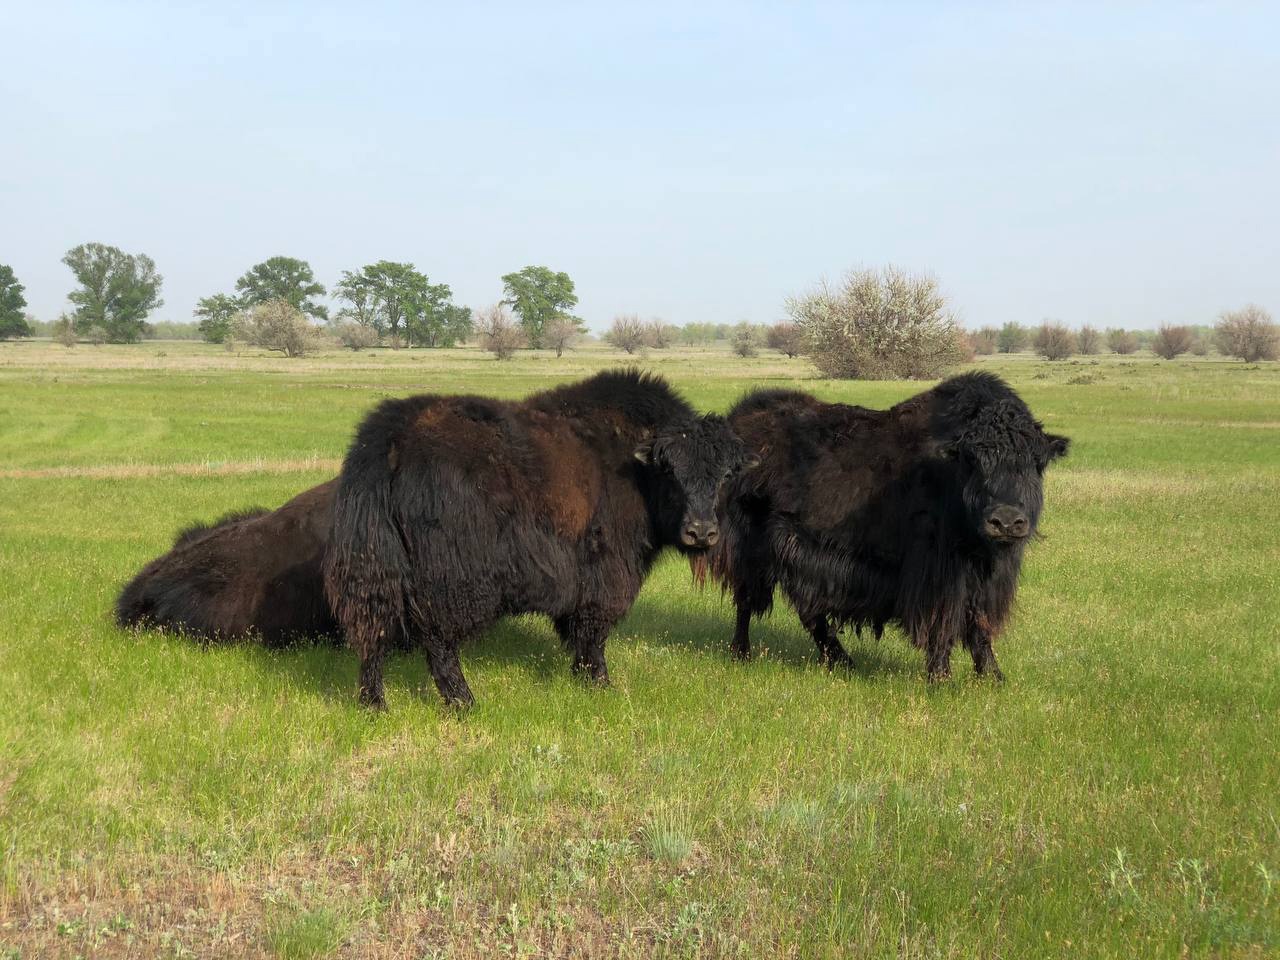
[787,266,968,380]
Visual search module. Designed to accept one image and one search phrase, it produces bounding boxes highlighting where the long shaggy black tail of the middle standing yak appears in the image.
[324,401,411,658]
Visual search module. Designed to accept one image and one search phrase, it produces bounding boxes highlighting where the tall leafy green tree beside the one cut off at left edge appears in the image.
[63,243,164,343]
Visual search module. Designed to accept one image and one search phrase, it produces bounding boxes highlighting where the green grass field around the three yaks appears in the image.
[0,343,1280,959]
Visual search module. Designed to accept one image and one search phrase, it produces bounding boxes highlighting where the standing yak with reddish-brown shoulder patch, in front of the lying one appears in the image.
[324,371,746,708]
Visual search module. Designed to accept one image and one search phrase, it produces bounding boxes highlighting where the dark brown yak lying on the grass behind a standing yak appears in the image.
[115,480,338,646]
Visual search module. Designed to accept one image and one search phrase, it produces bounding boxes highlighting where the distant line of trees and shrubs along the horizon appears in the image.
[0,252,1280,379]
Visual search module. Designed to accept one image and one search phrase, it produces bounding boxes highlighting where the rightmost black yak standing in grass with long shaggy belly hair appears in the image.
[712,372,1069,680]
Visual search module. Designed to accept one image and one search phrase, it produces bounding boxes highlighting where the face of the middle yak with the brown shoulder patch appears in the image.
[635,413,760,552]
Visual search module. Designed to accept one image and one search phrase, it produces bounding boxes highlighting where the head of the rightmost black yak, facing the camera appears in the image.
[942,399,1070,548]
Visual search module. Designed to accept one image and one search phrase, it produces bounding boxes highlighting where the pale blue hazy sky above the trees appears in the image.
[0,3,1280,329]
